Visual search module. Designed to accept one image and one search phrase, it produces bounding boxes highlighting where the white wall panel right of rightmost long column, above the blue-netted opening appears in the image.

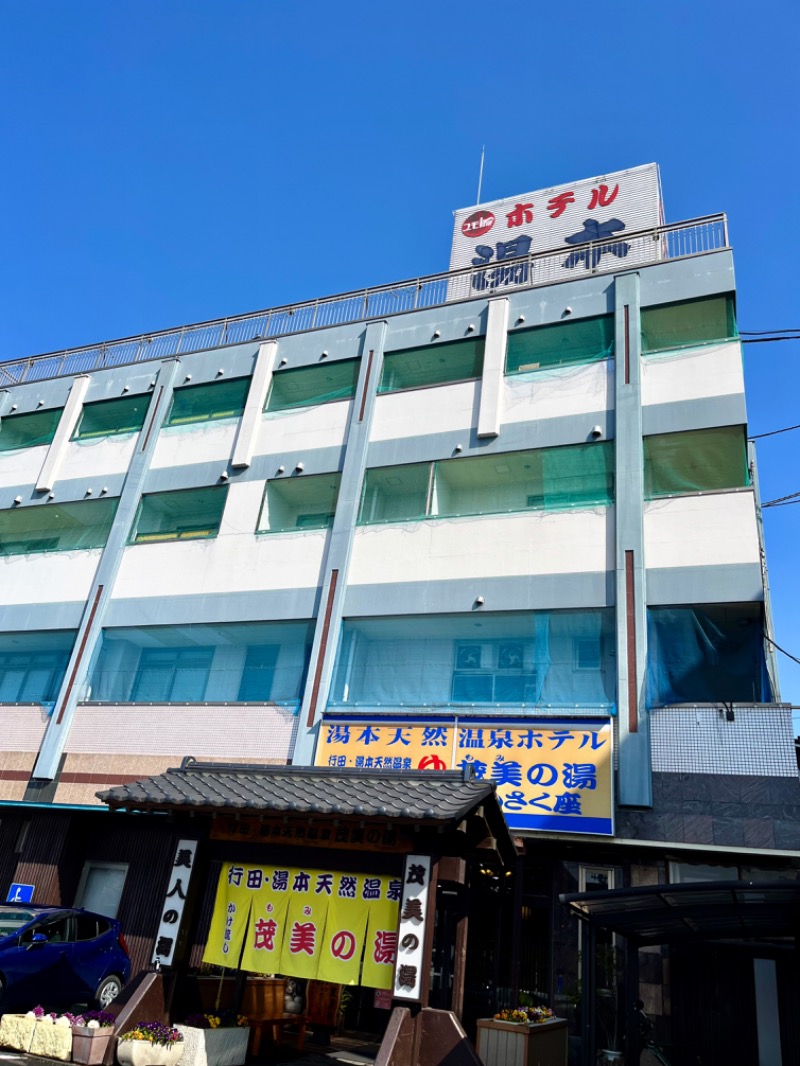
[644,490,758,569]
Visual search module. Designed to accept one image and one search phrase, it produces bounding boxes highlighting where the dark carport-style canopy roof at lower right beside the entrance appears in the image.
[559,881,800,944]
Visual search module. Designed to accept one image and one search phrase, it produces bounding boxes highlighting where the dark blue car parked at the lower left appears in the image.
[0,904,130,1012]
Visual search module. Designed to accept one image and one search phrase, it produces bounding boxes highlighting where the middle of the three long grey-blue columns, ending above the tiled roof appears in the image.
[292,322,386,766]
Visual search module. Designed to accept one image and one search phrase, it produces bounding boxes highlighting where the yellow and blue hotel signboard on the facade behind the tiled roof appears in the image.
[315,715,613,836]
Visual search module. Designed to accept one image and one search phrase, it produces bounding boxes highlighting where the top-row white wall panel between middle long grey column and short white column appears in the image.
[370,382,480,441]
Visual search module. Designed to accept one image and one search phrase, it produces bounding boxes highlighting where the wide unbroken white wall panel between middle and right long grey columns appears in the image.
[349,508,613,585]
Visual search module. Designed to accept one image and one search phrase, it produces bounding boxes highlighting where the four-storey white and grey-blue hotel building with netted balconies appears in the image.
[0,172,800,1057]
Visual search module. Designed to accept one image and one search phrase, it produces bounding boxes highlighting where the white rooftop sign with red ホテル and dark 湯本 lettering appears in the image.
[450,163,662,298]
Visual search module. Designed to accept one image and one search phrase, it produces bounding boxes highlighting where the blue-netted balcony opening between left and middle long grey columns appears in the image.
[90,621,311,704]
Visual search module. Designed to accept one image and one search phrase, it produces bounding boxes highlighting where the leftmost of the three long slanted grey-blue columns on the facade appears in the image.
[26,359,178,784]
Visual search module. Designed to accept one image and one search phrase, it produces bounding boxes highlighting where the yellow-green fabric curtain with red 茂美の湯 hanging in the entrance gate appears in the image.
[203,863,402,988]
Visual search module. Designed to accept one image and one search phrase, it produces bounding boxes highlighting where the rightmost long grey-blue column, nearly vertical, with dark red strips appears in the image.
[614,274,653,807]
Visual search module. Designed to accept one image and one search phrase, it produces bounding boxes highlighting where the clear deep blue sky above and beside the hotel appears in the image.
[0,0,800,720]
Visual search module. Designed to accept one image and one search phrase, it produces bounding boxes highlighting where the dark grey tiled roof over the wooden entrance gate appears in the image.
[97,756,516,860]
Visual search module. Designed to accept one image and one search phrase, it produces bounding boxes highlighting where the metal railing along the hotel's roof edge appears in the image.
[0,214,729,388]
